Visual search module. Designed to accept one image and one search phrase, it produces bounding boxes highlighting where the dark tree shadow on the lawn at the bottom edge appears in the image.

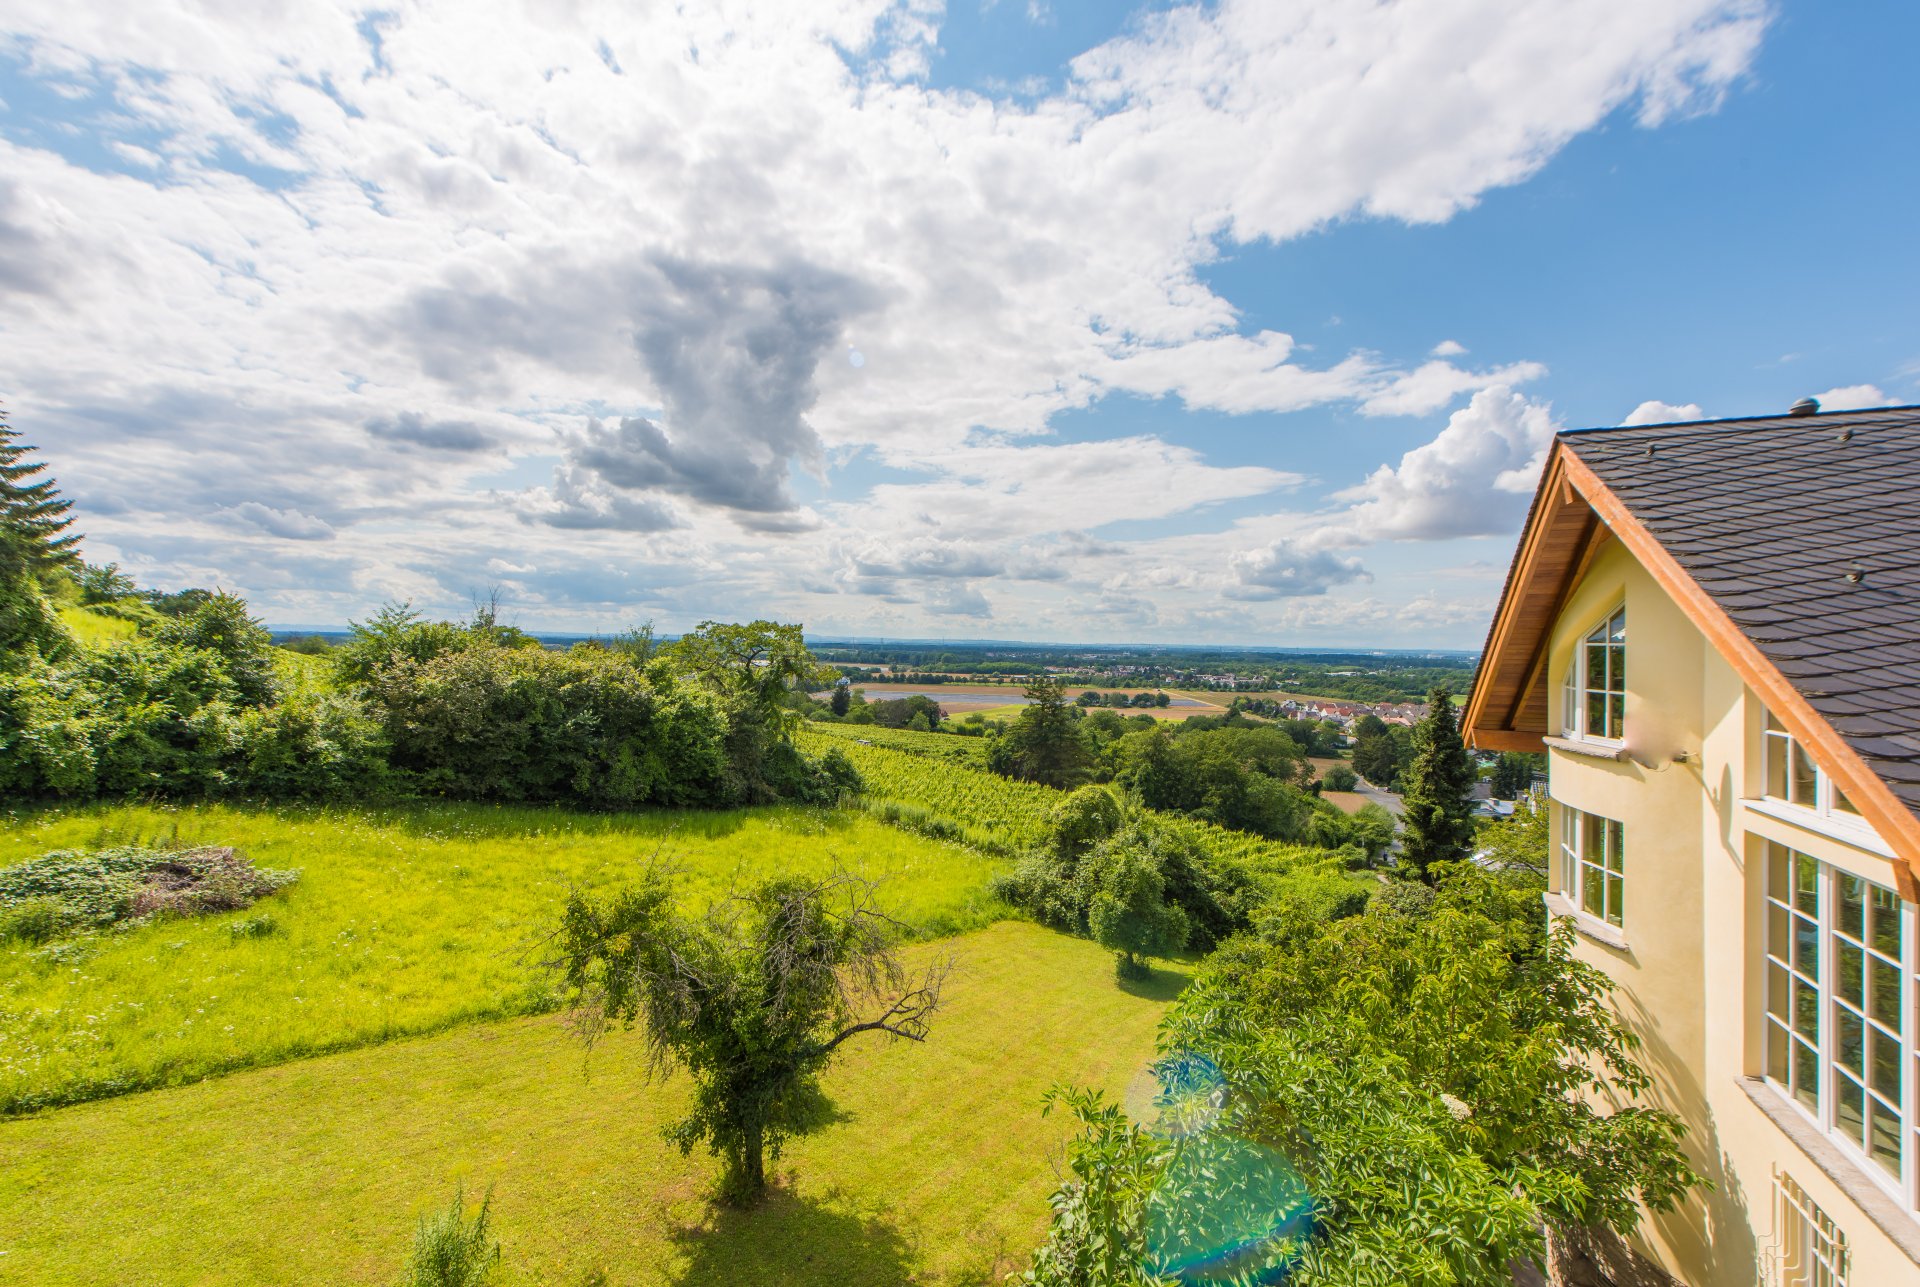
[668,1185,918,1287]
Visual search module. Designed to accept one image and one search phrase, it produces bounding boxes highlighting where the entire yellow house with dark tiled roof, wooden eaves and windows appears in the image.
[1463,407,1920,1287]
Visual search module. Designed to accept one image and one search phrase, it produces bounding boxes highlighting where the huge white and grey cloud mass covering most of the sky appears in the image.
[0,0,1764,632]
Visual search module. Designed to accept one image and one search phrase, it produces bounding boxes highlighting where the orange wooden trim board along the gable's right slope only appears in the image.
[1555,448,1920,899]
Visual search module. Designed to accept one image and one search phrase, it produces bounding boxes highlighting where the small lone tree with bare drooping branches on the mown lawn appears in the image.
[555,872,950,1202]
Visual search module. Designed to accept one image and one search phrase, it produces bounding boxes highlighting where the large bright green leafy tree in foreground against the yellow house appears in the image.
[1025,864,1701,1287]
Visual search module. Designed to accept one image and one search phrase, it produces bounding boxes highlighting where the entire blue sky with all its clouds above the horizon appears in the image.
[0,0,1920,647]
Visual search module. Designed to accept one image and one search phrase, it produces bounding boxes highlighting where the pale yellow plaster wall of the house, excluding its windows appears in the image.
[1548,542,1920,1287]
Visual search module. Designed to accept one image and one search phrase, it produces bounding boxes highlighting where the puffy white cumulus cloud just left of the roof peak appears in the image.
[1332,386,1559,544]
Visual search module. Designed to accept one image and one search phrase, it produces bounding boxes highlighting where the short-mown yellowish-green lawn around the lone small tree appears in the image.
[0,922,1185,1287]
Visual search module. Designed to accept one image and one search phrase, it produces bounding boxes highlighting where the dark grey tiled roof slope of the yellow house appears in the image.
[1561,407,1920,814]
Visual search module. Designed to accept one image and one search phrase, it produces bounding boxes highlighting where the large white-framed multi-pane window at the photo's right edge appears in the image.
[1766,841,1920,1210]
